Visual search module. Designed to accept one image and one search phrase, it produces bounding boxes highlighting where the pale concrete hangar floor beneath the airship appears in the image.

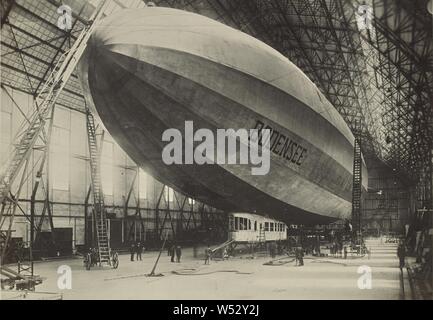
[1,240,402,300]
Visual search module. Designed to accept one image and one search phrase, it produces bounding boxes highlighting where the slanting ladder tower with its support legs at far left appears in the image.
[0,0,107,284]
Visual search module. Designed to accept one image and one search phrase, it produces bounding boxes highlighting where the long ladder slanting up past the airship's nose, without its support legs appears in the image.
[0,0,108,268]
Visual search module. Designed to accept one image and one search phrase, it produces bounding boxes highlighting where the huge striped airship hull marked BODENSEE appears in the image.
[79,7,368,224]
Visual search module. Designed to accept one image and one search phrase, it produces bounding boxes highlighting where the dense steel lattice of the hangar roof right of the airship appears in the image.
[203,0,433,184]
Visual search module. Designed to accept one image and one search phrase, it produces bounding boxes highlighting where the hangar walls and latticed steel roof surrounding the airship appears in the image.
[0,0,433,300]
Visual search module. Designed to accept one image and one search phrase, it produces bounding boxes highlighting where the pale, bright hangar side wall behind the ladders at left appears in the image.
[0,87,225,250]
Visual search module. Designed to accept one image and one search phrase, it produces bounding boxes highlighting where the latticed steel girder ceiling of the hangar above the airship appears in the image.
[1,0,433,181]
